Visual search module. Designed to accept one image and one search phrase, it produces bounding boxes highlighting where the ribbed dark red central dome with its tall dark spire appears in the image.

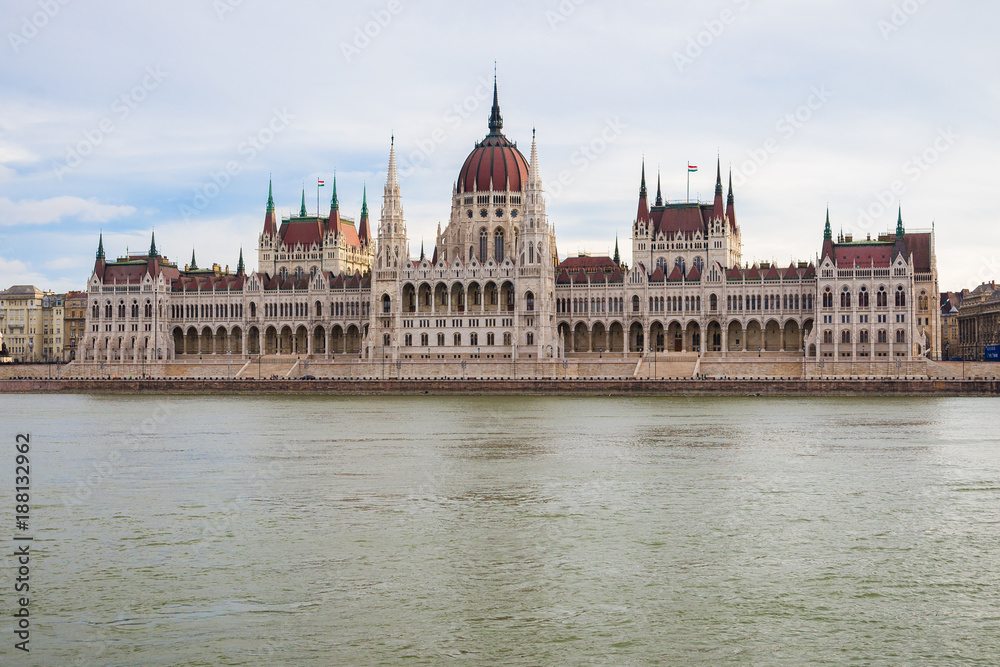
[457,80,528,192]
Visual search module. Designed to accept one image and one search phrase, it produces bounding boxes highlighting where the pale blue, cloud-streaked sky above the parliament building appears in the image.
[0,0,1000,291]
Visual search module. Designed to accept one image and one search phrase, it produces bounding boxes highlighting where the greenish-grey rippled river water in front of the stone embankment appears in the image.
[0,395,1000,665]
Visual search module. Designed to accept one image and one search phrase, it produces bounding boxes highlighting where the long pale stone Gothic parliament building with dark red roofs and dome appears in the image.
[76,81,940,368]
